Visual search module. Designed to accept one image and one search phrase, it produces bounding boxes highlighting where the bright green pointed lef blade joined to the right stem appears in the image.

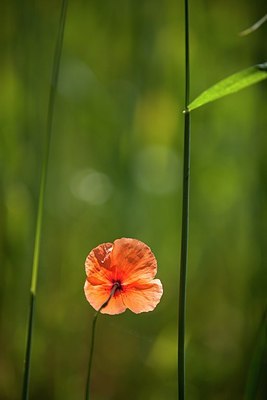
[188,62,267,111]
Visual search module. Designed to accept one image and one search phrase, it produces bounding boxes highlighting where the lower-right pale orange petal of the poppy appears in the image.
[121,279,163,314]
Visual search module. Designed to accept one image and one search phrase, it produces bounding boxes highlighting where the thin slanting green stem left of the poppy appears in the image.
[22,0,68,400]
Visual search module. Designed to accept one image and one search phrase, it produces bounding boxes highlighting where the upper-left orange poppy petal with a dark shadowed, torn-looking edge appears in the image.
[85,243,113,285]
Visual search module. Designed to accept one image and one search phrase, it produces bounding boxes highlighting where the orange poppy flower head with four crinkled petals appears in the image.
[84,238,163,314]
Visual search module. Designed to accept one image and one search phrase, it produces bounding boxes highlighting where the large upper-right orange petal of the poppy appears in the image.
[111,238,157,284]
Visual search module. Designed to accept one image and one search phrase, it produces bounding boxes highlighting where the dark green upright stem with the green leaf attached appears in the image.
[178,0,190,400]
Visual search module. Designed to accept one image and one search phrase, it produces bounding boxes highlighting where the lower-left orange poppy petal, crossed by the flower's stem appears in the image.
[84,280,126,315]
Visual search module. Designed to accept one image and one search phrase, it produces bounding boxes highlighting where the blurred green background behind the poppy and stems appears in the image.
[0,0,267,400]
